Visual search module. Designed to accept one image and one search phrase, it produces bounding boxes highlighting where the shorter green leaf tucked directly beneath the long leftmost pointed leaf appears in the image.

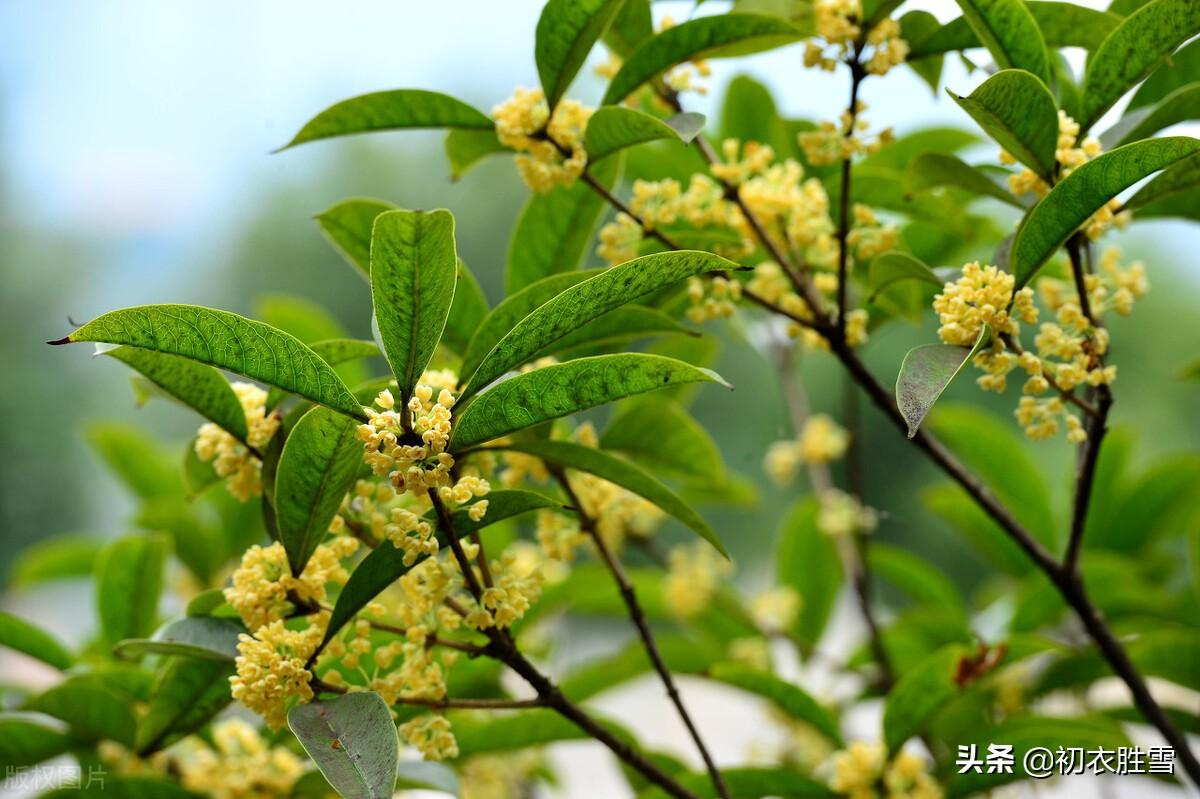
[104,347,247,441]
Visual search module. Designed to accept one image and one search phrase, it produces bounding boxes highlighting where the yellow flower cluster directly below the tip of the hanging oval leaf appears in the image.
[224,537,359,631]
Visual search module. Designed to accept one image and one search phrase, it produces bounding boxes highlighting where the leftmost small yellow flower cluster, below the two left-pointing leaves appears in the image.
[196,383,280,501]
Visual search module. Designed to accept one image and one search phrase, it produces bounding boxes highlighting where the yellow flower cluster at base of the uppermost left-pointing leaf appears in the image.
[492,89,592,194]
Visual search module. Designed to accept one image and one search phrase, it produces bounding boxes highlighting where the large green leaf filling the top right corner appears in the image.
[1079,0,1200,132]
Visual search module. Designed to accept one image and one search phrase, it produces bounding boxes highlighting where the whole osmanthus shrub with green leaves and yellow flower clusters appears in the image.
[9,0,1200,799]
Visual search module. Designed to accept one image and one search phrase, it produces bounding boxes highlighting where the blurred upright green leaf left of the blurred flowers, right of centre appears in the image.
[775,499,842,651]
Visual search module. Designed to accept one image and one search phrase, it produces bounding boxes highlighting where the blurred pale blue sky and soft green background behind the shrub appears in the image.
[0,0,1200,795]
